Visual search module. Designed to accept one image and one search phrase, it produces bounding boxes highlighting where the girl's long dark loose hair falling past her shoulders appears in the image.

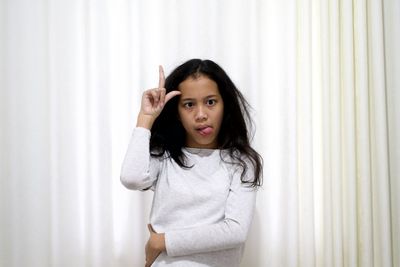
[150,59,262,187]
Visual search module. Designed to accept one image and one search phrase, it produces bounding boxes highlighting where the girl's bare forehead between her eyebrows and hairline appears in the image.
[178,76,220,99]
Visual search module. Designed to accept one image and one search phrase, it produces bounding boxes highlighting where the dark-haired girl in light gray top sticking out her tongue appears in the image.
[121,59,262,267]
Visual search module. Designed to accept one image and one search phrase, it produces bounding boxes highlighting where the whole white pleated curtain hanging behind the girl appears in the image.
[0,0,400,267]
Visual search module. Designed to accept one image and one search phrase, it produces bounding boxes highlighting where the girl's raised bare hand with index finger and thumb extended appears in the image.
[136,66,181,129]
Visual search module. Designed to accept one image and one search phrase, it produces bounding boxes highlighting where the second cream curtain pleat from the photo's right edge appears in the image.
[367,1,392,266]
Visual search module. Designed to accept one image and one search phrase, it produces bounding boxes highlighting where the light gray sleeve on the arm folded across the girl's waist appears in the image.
[165,170,257,256]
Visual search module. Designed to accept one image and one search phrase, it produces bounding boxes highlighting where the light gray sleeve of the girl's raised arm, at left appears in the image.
[120,127,159,190]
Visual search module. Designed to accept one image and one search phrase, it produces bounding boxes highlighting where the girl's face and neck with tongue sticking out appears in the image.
[178,76,224,148]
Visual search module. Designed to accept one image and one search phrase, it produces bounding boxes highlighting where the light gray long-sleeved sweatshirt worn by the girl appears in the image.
[121,127,256,267]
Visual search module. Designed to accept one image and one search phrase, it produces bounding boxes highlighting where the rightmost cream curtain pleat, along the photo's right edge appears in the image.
[382,0,400,266]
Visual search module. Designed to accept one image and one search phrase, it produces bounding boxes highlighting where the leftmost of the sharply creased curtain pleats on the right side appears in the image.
[295,1,315,266]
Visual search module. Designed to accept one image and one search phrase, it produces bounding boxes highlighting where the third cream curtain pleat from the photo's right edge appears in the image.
[354,1,374,266]
